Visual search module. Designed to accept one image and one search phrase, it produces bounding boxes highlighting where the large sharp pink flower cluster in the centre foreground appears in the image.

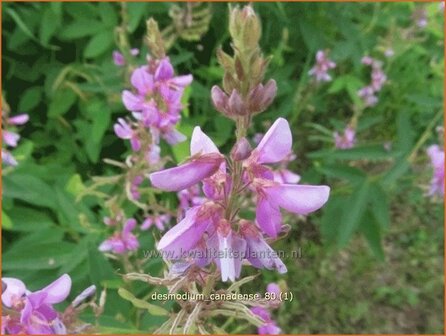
[149,118,329,281]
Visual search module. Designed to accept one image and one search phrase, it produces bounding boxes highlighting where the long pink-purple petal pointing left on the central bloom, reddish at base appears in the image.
[149,154,224,191]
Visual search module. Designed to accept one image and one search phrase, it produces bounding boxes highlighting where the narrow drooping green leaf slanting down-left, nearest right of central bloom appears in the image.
[338,181,370,247]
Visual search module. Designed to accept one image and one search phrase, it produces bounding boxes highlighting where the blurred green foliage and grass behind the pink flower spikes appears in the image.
[2,2,444,333]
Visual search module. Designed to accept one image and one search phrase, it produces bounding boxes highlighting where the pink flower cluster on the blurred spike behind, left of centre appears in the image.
[114,57,192,163]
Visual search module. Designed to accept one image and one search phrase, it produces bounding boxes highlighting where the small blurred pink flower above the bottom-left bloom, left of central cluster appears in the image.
[99,218,139,254]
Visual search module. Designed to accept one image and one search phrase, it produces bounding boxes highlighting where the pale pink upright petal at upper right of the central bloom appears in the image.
[255,118,293,163]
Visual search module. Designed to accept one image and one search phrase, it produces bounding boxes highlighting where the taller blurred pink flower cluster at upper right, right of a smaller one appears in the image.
[358,56,387,107]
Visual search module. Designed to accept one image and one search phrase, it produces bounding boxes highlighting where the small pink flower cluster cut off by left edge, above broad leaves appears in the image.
[2,111,29,166]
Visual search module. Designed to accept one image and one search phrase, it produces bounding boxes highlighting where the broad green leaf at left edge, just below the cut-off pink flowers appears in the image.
[3,173,56,208]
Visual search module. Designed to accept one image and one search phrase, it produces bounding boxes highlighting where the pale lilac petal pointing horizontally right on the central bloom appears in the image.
[265,184,330,215]
